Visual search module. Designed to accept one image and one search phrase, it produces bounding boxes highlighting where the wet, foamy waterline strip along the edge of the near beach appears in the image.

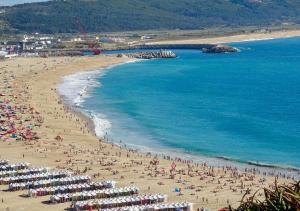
[57,55,300,179]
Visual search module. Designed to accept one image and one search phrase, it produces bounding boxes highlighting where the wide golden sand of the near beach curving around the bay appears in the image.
[0,55,296,211]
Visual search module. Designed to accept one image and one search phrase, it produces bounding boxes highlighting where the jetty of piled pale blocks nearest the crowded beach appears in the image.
[126,50,176,59]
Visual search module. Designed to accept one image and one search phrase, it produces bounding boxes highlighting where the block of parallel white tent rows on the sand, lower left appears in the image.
[0,160,192,211]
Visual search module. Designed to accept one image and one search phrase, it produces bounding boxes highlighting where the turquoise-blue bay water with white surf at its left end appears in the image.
[60,38,300,171]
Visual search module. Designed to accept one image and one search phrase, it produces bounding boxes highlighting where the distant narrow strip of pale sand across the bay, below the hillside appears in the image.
[149,30,300,44]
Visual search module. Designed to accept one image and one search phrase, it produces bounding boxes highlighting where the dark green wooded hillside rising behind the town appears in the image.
[0,0,300,33]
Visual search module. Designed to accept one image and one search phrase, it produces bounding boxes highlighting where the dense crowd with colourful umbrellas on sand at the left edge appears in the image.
[0,71,43,141]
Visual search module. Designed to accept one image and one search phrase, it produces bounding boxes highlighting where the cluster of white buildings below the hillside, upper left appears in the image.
[0,33,157,59]
